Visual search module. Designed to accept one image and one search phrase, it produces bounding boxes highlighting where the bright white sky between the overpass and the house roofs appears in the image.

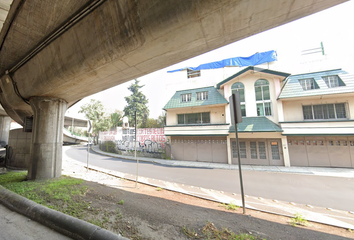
[66,0,354,118]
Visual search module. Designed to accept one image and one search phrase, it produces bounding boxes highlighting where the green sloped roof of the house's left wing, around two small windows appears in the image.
[164,87,229,109]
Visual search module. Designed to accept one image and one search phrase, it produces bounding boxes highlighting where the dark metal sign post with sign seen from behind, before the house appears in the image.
[229,91,246,214]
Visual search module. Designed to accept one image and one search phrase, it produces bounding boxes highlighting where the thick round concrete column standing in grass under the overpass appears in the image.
[27,97,67,180]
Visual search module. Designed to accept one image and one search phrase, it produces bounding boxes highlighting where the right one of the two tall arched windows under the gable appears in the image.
[254,79,272,116]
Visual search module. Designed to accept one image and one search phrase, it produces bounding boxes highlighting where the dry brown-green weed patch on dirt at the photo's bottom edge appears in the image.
[182,222,261,240]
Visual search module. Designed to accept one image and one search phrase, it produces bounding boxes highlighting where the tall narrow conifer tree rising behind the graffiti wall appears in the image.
[123,79,149,126]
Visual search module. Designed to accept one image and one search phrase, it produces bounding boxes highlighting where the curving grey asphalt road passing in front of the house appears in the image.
[64,147,354,211]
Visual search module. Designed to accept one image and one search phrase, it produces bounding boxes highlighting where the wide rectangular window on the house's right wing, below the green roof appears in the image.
[302,103,347,120]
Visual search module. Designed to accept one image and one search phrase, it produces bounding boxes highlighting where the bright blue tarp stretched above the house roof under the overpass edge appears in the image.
[167,50,277,73]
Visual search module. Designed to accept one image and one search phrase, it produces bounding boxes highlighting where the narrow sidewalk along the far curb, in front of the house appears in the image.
[91,146,354,178]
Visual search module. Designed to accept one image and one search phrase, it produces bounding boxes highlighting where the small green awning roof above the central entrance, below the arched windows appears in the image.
[229,117,283,132]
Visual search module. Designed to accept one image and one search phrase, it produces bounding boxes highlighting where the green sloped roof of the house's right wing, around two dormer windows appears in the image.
[279,69,354,99]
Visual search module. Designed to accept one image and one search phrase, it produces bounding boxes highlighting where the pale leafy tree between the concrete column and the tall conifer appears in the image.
[79,99,110,143]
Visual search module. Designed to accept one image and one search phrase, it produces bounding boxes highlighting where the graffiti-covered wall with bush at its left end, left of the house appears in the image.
[99,127,171,159]
